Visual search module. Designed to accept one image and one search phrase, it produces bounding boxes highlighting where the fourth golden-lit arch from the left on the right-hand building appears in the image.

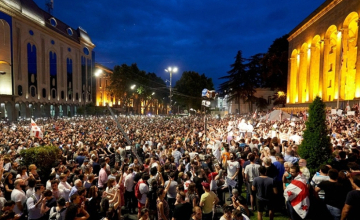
[323,25,338,101]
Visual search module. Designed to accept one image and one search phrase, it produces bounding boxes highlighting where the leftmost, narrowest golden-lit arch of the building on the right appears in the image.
[290,49,298,103]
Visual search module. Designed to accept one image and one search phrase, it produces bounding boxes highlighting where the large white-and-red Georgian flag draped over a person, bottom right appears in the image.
[284,174,310,219]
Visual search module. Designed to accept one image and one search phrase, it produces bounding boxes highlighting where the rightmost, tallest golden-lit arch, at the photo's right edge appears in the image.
[341,12,360,100]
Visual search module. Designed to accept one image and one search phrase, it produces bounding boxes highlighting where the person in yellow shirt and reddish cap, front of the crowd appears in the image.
[200,182,219,220]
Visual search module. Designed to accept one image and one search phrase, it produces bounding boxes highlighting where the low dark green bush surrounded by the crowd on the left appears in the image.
[20,146,60,183]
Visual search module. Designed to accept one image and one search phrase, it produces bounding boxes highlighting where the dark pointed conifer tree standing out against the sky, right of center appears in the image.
[219,50,257,112]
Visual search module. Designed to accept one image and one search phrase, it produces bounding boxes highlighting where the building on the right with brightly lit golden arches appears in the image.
[287,0,360,104]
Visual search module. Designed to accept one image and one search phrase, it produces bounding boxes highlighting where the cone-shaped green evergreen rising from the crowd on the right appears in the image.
[298,97,332,174]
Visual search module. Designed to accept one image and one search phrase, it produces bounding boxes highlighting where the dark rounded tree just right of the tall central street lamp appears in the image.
[173,71,214,109]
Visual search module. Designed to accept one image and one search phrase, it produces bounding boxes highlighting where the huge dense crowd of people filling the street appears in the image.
[0,110,360,220]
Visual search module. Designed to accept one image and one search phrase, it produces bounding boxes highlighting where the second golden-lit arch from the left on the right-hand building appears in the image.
[298,43,309,103]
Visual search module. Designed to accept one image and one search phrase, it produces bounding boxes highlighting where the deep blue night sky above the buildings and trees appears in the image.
[35,0,325,88]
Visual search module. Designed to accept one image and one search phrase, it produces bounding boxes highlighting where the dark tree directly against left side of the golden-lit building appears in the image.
[261,35,289,91]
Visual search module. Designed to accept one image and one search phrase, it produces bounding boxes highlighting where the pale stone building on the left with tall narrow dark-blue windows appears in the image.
[0,0,95,120]
